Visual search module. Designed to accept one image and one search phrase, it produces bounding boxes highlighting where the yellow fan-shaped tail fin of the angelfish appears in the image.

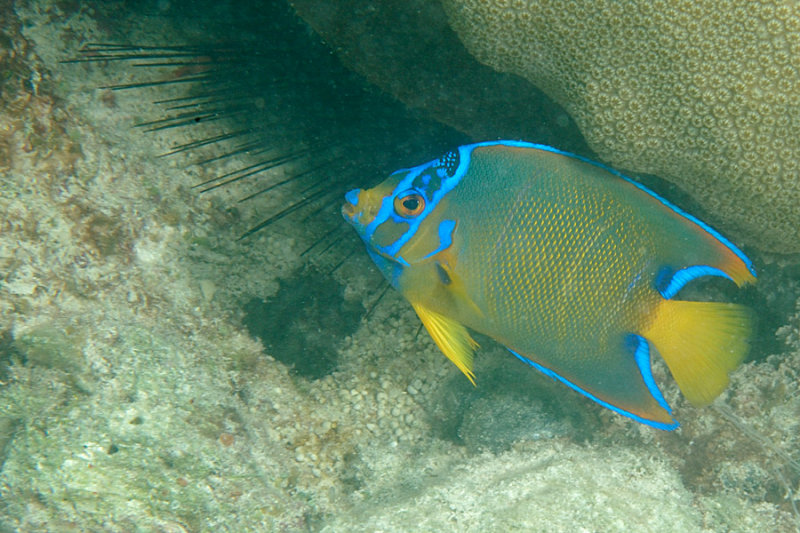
[642,300,754,406]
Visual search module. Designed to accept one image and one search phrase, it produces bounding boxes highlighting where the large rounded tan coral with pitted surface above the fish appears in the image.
[442,0,800,253]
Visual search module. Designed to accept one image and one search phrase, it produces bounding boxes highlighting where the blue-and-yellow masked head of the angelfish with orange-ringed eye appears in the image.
[342,151,463,287]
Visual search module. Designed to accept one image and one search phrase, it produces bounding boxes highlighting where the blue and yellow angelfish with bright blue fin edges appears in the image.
[342,140,756,430]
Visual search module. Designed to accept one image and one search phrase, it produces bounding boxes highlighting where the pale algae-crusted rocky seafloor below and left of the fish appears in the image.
[0,1,800,532]
